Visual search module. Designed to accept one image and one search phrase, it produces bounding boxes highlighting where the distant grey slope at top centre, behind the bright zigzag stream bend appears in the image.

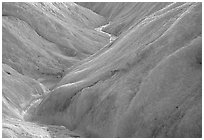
[77,2,175,36]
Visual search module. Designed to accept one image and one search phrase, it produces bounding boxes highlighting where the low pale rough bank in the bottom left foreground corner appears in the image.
[2,118,80,138]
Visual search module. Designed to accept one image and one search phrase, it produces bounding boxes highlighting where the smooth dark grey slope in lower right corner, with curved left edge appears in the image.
[117,37,202,137]
